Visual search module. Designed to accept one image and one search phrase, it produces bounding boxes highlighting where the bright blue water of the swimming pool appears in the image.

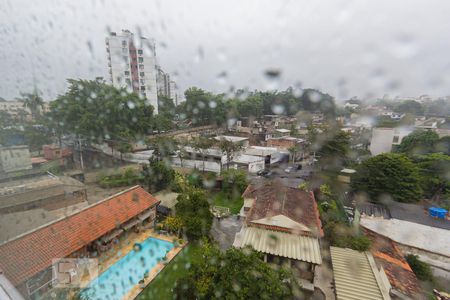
[83,238,173,300]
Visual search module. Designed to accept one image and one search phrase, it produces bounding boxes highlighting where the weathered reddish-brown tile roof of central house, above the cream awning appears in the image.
[242,180,323,237]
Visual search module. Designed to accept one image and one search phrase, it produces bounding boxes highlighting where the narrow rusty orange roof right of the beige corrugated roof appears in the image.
[363,228,421,299]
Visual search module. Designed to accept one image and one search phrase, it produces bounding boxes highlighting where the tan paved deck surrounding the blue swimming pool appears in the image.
[82,229,187,300]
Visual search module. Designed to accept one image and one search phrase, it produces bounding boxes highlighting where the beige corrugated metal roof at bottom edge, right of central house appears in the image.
[330,247,390,300]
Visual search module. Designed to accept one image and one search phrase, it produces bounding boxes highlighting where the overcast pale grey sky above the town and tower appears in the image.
[0,0,450,100]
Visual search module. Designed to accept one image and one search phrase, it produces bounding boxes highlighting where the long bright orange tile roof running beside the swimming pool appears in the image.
[0,186,159,285]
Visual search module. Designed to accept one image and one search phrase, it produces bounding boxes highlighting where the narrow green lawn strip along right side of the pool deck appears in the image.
[137,244,201,300]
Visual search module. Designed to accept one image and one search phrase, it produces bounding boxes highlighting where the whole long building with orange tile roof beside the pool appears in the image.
[0,186,159,299]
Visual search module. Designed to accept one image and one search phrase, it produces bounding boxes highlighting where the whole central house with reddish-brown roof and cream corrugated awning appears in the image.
[233,180,323,288]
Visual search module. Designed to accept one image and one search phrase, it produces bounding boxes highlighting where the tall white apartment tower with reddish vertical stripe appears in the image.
[106,30,158,114]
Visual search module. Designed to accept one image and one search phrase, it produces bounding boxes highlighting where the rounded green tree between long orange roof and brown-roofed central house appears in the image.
[175,187,213,240]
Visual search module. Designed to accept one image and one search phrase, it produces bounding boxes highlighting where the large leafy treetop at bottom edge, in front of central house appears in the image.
[174,243,300,299]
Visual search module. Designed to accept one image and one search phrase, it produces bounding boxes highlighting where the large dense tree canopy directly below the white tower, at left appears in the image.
[49,79,153,141]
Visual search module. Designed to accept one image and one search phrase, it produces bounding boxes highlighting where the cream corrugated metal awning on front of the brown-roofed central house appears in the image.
[234,227,322,264]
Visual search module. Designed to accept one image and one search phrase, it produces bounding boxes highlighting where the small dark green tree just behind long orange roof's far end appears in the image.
[142,158,175,192]
